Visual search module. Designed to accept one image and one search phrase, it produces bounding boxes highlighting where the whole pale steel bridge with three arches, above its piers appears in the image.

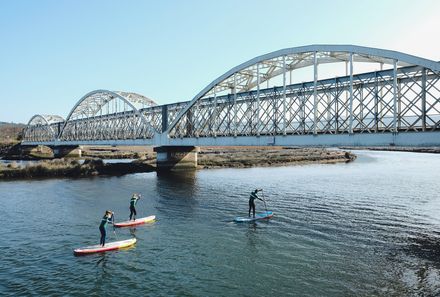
[23,45,440,146]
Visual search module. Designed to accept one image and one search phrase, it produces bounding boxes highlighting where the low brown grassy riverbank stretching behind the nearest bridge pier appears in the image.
[0,147,356,179]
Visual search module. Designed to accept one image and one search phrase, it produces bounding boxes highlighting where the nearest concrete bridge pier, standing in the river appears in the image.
[154,146,200,171]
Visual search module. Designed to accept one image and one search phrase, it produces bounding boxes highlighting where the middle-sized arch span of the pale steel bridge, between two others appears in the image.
[58,90,159,141]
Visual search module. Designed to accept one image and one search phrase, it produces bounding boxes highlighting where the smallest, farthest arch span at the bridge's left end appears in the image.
[23,114,64,142]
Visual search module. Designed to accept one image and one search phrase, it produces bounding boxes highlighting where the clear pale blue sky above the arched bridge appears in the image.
[0,0,440,122]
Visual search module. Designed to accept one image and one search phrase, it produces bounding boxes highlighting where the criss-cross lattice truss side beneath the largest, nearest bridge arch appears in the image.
[170,66,440,138]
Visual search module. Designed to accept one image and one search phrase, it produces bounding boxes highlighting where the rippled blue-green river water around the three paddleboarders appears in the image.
[0,151,440,296]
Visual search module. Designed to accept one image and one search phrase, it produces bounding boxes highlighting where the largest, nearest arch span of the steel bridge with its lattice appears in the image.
[167,45,440,138]
